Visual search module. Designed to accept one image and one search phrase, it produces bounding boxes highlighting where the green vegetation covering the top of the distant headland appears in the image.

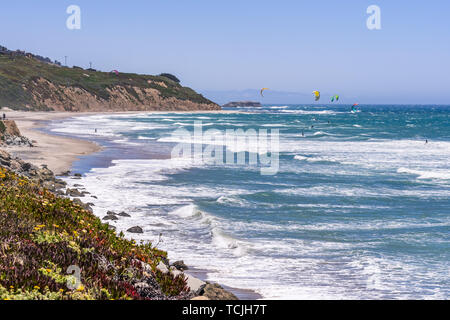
[0,54,213,111]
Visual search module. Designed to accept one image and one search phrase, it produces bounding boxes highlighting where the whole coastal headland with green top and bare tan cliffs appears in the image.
[0,50,220,111]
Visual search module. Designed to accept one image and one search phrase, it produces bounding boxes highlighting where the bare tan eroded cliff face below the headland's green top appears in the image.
[24,78,221,112]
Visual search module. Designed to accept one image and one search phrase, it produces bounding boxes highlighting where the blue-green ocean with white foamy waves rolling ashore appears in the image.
[48,104,450,299]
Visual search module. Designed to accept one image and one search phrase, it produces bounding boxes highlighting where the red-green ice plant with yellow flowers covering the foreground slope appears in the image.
[0,167,188,300]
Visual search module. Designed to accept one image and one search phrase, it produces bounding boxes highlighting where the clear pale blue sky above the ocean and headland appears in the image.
[0,0,450,104]
